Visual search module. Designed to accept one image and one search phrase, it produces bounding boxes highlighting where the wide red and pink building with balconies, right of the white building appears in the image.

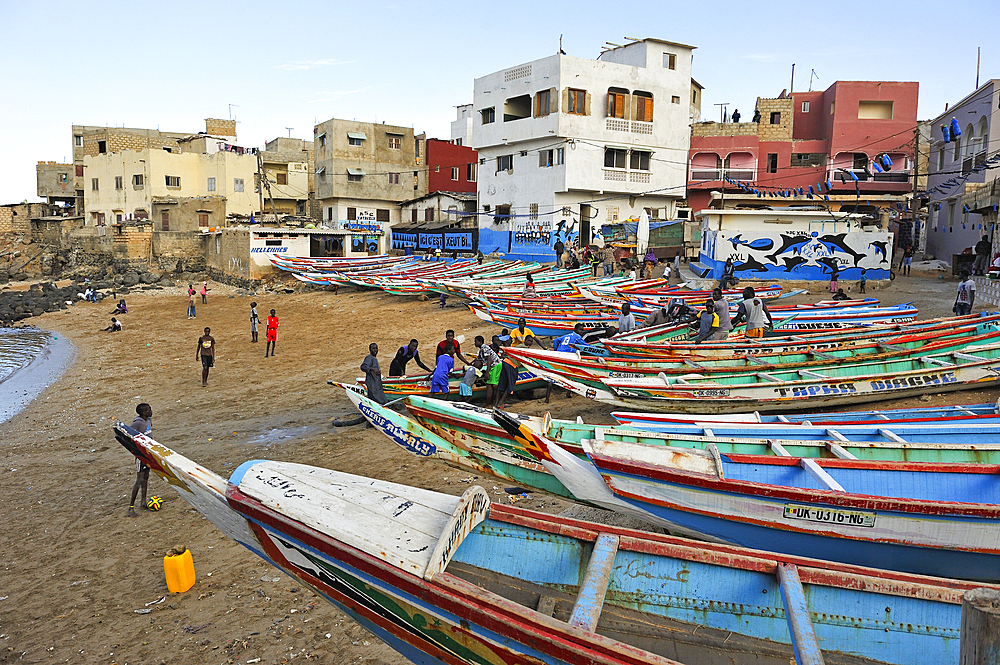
[688,81,918,212]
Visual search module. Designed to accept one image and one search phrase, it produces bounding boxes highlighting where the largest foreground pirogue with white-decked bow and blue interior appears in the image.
[114,423,1000,665]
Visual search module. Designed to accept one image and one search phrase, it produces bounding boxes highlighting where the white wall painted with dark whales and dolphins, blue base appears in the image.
[701,231,892,280]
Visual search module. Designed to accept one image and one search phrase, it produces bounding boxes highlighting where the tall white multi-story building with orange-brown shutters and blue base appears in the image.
[472,39,700,260]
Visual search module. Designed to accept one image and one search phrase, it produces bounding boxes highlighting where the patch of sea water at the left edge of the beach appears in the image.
[0,328,76,423]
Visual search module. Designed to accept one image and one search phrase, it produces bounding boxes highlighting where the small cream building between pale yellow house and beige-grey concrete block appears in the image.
[259,137,320,220]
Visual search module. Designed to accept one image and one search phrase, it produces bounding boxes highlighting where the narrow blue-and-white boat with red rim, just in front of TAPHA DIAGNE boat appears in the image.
[611,402,1000,427]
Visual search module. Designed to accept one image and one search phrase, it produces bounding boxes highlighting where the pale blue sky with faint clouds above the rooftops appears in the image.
[0,0,1000,204]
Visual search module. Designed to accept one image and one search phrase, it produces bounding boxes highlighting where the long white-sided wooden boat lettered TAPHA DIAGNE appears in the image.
[531,344,1000,413]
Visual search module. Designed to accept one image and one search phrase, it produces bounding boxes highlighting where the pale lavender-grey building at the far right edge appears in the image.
[926,79,1000,263]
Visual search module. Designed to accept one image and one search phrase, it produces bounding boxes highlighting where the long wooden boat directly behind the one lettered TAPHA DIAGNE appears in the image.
[507,326,1000,388]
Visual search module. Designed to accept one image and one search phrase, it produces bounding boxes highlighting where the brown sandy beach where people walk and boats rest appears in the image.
[0,273,997,665]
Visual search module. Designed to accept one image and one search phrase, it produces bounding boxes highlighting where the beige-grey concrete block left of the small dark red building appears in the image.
[313,118,427,251]
